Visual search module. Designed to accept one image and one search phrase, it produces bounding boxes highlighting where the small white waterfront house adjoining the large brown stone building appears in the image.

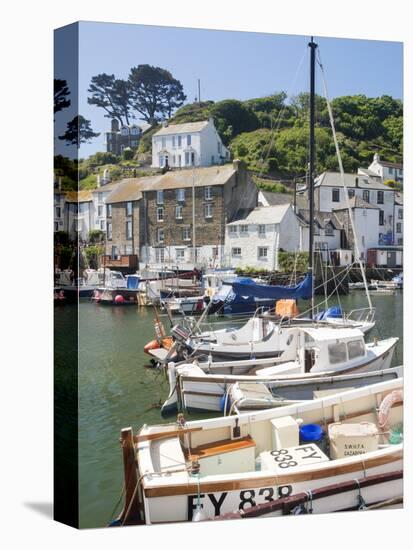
[225,204,301,271]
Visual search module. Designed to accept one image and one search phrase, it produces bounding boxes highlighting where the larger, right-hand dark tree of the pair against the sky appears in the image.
[128,65,186,124]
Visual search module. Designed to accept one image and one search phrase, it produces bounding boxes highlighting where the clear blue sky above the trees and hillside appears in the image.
[55,22,403,158]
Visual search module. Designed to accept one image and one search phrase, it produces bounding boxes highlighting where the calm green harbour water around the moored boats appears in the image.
[56,292,403,527]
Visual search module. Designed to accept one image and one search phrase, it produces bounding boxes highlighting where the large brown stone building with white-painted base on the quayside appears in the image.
[106,161,257,269]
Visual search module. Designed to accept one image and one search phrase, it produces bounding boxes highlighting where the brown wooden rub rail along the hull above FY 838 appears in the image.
[144,451,403,498]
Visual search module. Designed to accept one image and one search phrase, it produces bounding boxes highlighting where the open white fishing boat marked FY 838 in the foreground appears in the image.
[120,379,403,524]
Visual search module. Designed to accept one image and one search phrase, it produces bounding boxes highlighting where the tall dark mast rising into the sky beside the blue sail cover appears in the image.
[308,37,317,317]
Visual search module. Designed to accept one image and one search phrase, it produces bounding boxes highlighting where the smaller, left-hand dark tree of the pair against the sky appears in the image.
[87,73,133,126]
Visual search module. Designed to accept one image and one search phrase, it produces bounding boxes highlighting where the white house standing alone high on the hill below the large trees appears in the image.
[152,118,230,168]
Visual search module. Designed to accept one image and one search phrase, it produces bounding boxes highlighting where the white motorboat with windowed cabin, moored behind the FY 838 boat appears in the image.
[162,329,398,415]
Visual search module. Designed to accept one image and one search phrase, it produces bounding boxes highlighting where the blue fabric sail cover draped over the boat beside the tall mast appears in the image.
[230,273,312,300]
